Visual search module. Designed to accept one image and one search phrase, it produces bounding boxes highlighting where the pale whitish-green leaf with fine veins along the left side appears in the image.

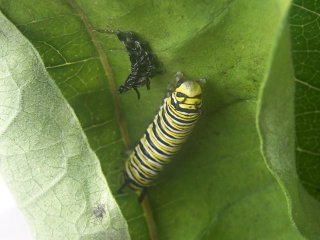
[0,10,129,239]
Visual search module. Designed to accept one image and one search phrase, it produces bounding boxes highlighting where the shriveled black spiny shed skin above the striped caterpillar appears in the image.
[97,30,161,99]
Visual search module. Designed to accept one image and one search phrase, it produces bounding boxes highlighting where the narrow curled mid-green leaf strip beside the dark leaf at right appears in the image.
[258,21,299,235]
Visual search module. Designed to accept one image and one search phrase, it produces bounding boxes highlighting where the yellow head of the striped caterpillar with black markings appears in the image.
[172,81,202,110]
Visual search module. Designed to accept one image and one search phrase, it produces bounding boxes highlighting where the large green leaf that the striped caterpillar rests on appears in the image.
[0,0,302,240]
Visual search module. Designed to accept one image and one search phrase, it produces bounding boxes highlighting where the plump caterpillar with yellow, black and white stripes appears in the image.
[119,73,202,200]
